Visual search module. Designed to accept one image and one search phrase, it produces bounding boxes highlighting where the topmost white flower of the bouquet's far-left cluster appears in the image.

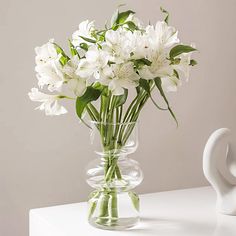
[35,39,59,65]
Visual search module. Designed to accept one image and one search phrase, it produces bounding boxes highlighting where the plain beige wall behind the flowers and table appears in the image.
[0,0,236,236]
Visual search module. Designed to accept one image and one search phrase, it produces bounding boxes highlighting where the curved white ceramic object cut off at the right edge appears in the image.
[203,128,236,215]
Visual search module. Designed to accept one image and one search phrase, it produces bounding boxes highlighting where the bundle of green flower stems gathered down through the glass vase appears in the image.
[94,88,153,225]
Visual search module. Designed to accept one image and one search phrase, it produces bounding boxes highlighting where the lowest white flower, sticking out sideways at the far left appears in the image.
[28,88,67,116]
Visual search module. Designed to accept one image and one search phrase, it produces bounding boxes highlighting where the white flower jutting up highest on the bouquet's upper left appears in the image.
[72,20,95,47]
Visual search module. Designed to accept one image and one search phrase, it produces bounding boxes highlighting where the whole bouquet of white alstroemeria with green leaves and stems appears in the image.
[29,9,196,230]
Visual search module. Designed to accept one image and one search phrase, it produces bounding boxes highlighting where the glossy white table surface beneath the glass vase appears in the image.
[30,187,236,236]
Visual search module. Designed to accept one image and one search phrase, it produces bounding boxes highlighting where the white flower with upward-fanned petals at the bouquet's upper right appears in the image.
[146,21,179,51]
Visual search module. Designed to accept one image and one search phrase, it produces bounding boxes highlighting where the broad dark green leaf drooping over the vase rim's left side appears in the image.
[76,86,101,121]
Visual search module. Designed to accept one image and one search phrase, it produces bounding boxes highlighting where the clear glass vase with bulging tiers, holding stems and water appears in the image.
[86,122,143,230]
